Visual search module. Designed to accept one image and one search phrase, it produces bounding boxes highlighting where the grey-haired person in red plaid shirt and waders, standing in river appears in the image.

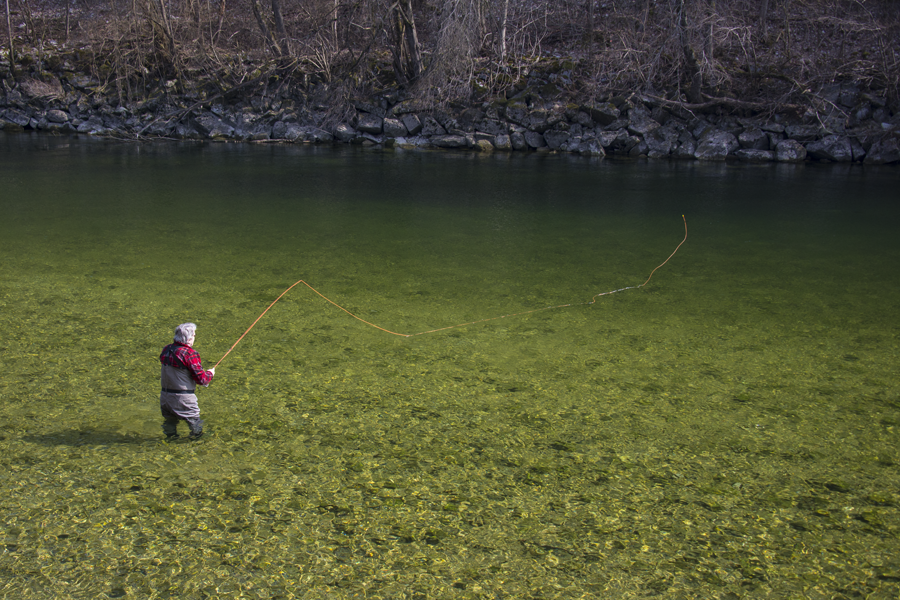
[159,323,216,440]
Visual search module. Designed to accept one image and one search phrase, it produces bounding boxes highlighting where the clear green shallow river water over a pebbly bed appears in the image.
[0,135,900,598]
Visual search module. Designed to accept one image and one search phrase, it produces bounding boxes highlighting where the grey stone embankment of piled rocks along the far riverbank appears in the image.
[0,76,900,164]
